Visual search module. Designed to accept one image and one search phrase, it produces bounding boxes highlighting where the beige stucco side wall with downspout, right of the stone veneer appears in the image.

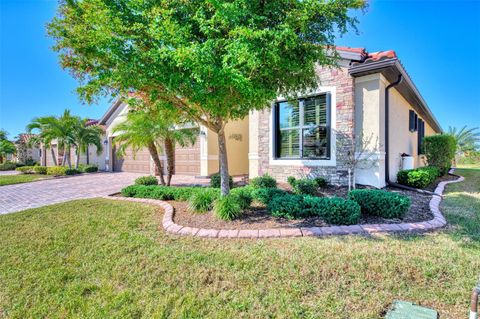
[355,73,439,187]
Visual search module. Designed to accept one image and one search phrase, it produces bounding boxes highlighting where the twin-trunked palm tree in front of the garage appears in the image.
[114,107,197,185]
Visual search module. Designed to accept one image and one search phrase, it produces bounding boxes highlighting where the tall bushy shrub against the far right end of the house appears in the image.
[422,134,456,175]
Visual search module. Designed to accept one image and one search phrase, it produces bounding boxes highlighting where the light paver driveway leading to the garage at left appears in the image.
[0,172,144,214]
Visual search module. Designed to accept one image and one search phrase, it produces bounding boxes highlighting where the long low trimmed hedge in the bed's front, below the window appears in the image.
[267,194,361,225]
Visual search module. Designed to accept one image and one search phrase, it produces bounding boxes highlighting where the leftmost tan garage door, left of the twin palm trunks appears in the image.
[113,144,150,174]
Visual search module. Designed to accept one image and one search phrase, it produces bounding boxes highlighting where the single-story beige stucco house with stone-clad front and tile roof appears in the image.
[41,47,442,188]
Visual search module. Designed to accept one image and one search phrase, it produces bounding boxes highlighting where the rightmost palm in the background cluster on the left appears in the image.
[72,119,103,168]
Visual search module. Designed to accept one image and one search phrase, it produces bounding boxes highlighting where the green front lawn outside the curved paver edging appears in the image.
[0,170,480,319]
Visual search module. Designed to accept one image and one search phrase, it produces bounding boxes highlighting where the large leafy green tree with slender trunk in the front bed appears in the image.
[48,0,365,195]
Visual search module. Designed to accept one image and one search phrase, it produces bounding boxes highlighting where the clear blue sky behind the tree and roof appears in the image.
[0,0,480,137]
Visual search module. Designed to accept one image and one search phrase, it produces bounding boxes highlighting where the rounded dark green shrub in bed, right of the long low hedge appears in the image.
[348,189,411,218]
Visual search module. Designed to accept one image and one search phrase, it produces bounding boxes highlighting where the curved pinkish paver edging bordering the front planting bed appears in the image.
[105,170,464,238]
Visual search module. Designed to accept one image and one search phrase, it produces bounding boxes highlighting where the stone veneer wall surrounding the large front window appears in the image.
[258,63,354,185]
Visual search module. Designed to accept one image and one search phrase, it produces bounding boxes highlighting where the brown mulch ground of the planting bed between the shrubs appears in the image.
[169,176,450,229]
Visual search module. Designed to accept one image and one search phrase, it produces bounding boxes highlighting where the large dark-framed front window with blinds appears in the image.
[274,94,330,159]
